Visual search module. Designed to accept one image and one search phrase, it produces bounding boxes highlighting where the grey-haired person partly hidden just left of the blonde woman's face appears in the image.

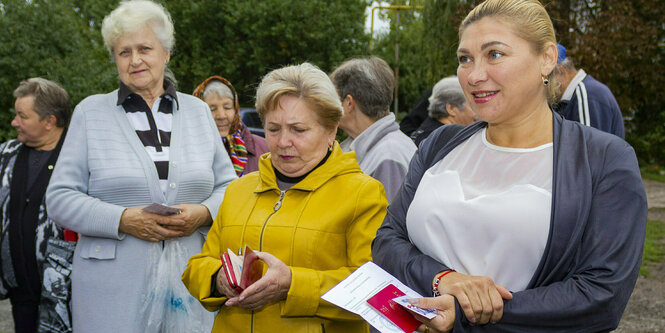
[411,75,476,145]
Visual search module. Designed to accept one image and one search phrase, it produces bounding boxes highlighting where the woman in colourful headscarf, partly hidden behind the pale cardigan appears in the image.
[194,76,268,177]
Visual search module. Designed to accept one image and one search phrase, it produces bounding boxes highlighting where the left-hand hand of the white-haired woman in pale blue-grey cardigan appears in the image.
[118,207,183,242]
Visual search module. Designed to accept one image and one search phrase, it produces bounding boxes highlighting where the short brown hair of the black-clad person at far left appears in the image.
[14,77,72,127]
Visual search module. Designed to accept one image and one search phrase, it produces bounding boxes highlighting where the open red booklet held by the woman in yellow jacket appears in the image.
[221,245,263,293]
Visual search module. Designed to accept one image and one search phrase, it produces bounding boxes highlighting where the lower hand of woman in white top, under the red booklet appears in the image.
[409,295,455,333]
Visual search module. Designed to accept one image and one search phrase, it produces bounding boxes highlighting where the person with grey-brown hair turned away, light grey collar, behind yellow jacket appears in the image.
[330,57,416,201]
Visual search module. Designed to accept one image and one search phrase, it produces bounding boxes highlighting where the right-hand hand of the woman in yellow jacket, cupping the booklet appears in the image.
[225,252,291,311]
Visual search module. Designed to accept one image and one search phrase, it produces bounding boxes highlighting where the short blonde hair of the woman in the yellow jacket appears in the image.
[256,62,344,130]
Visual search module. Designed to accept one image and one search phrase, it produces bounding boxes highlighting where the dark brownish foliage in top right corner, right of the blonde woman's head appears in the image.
[548,0,665,164]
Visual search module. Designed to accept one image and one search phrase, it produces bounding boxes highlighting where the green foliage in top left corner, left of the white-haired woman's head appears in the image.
[0,0,116,141]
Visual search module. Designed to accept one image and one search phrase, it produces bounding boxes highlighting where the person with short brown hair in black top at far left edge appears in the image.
[0,78,71,333]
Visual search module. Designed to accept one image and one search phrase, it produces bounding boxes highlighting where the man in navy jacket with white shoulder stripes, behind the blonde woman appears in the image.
[554,44,624,139]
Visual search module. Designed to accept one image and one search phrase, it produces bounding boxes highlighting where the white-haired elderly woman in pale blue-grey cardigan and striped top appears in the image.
[46,0,236,333]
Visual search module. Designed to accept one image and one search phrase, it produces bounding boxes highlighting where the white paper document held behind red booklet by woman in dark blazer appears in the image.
[321,261,422,333]
